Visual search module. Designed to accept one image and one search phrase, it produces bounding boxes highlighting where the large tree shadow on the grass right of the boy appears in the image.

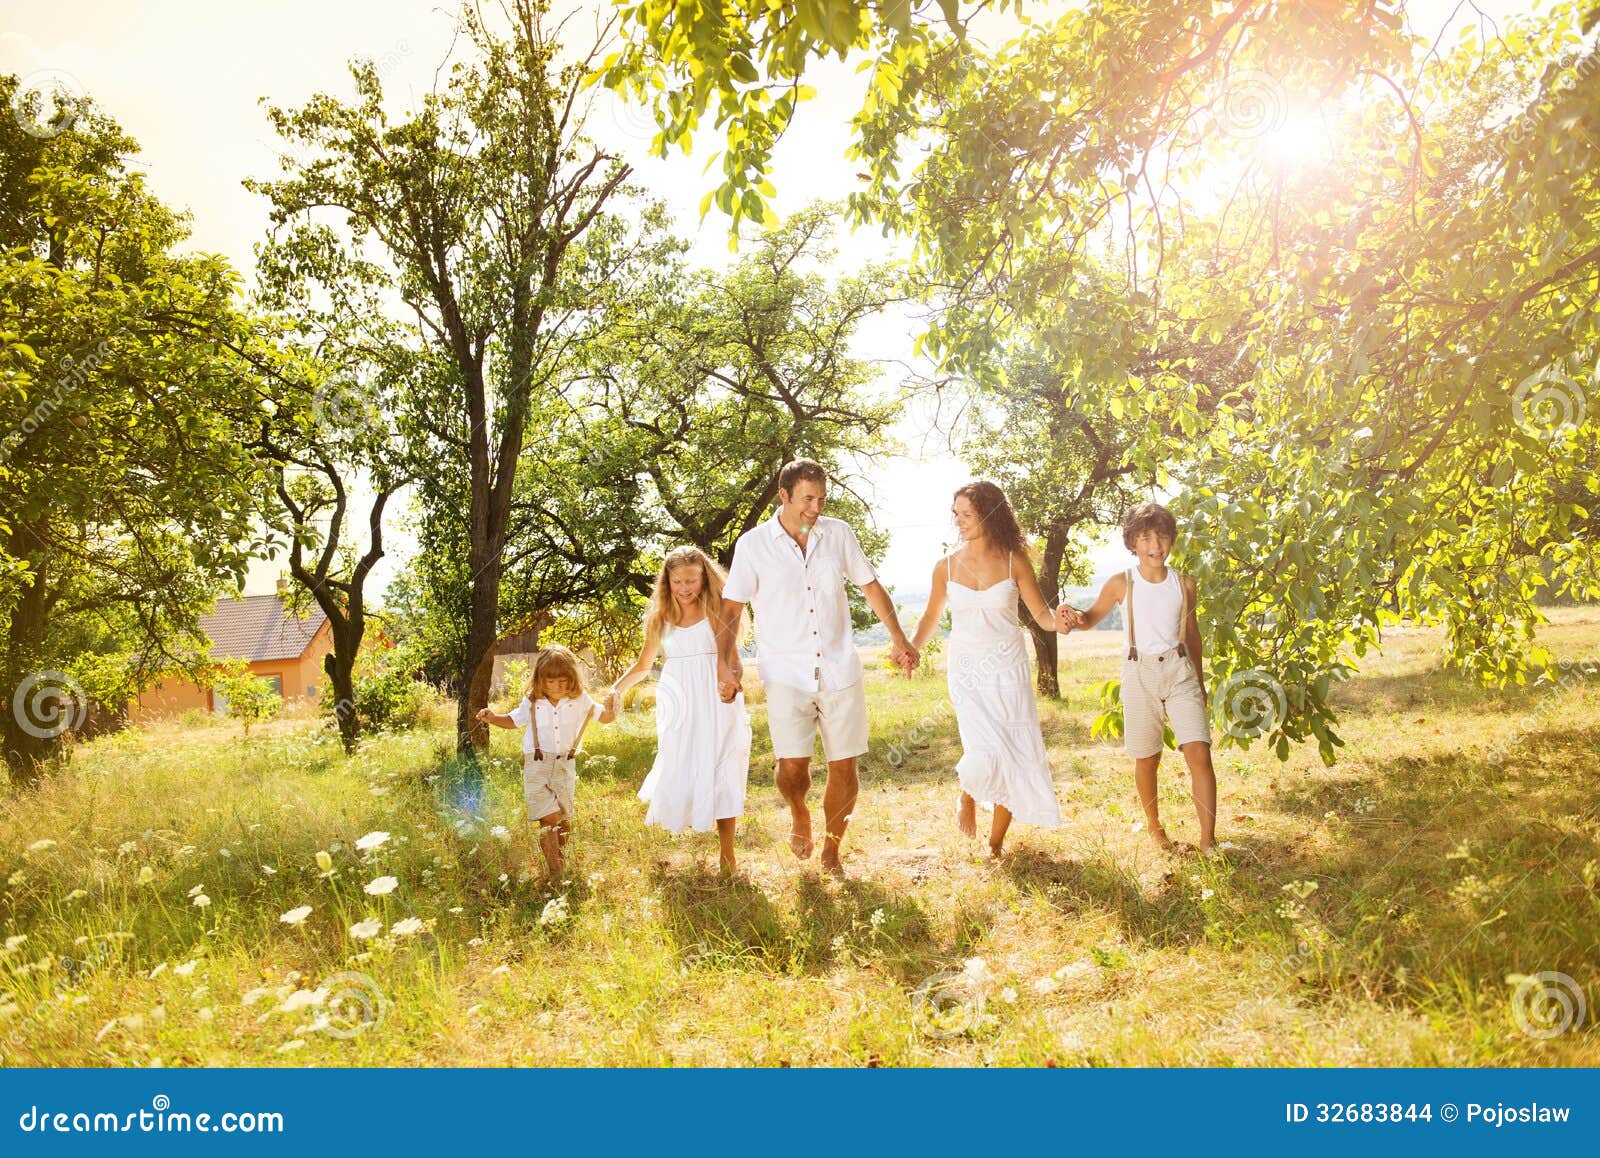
[1224,728,1600,1009]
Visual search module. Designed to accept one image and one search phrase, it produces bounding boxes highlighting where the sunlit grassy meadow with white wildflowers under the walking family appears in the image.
[0,608,1600,1067]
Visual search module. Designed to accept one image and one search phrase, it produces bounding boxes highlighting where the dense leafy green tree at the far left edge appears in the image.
[0,77,270,784]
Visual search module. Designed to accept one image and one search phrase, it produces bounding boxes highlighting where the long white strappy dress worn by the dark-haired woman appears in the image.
[946,559,1061,827]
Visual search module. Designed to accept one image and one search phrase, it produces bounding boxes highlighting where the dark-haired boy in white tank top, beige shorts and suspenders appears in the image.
[1056,502,1216,856]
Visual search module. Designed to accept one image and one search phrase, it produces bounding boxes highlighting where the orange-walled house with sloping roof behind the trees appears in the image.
[128,581,333,721]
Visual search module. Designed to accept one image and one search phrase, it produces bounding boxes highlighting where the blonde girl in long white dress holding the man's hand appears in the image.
[614,547,750,873]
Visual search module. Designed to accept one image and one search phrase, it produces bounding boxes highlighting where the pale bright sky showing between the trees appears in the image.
[0,0,1530,595]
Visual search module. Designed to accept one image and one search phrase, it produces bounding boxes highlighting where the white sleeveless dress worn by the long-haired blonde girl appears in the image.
[638,619,750,832]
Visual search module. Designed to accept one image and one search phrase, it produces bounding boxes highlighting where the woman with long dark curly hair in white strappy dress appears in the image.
[912,483,1061,857]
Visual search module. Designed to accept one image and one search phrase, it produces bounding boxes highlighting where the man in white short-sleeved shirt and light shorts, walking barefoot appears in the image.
[717,459,918,872]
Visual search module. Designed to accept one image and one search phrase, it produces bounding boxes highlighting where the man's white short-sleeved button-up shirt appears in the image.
[722,515,878,693]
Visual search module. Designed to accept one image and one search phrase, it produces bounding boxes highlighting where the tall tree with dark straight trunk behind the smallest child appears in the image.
[251,0,630,752]
